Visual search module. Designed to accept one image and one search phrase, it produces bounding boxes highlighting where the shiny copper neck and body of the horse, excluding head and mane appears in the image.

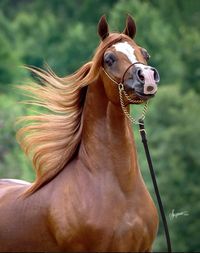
[0,15,158,252]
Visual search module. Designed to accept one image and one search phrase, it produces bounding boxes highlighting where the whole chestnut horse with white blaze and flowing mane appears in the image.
[0,16,158,252]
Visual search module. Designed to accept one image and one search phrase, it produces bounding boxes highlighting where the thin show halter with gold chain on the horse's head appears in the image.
[102,62,148,124]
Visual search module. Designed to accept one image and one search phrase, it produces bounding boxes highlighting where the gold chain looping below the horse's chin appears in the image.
[118,83,148,124]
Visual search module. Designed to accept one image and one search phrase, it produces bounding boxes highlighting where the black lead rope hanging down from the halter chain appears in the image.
[139,119,172,253]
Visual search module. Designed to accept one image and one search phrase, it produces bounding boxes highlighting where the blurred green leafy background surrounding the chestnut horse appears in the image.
[0,0,200,252]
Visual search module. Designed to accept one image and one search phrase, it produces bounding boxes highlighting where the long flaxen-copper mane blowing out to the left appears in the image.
[17,33,126,194]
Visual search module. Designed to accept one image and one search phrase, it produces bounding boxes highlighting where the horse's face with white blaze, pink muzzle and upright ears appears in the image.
[99,16,160,104]
